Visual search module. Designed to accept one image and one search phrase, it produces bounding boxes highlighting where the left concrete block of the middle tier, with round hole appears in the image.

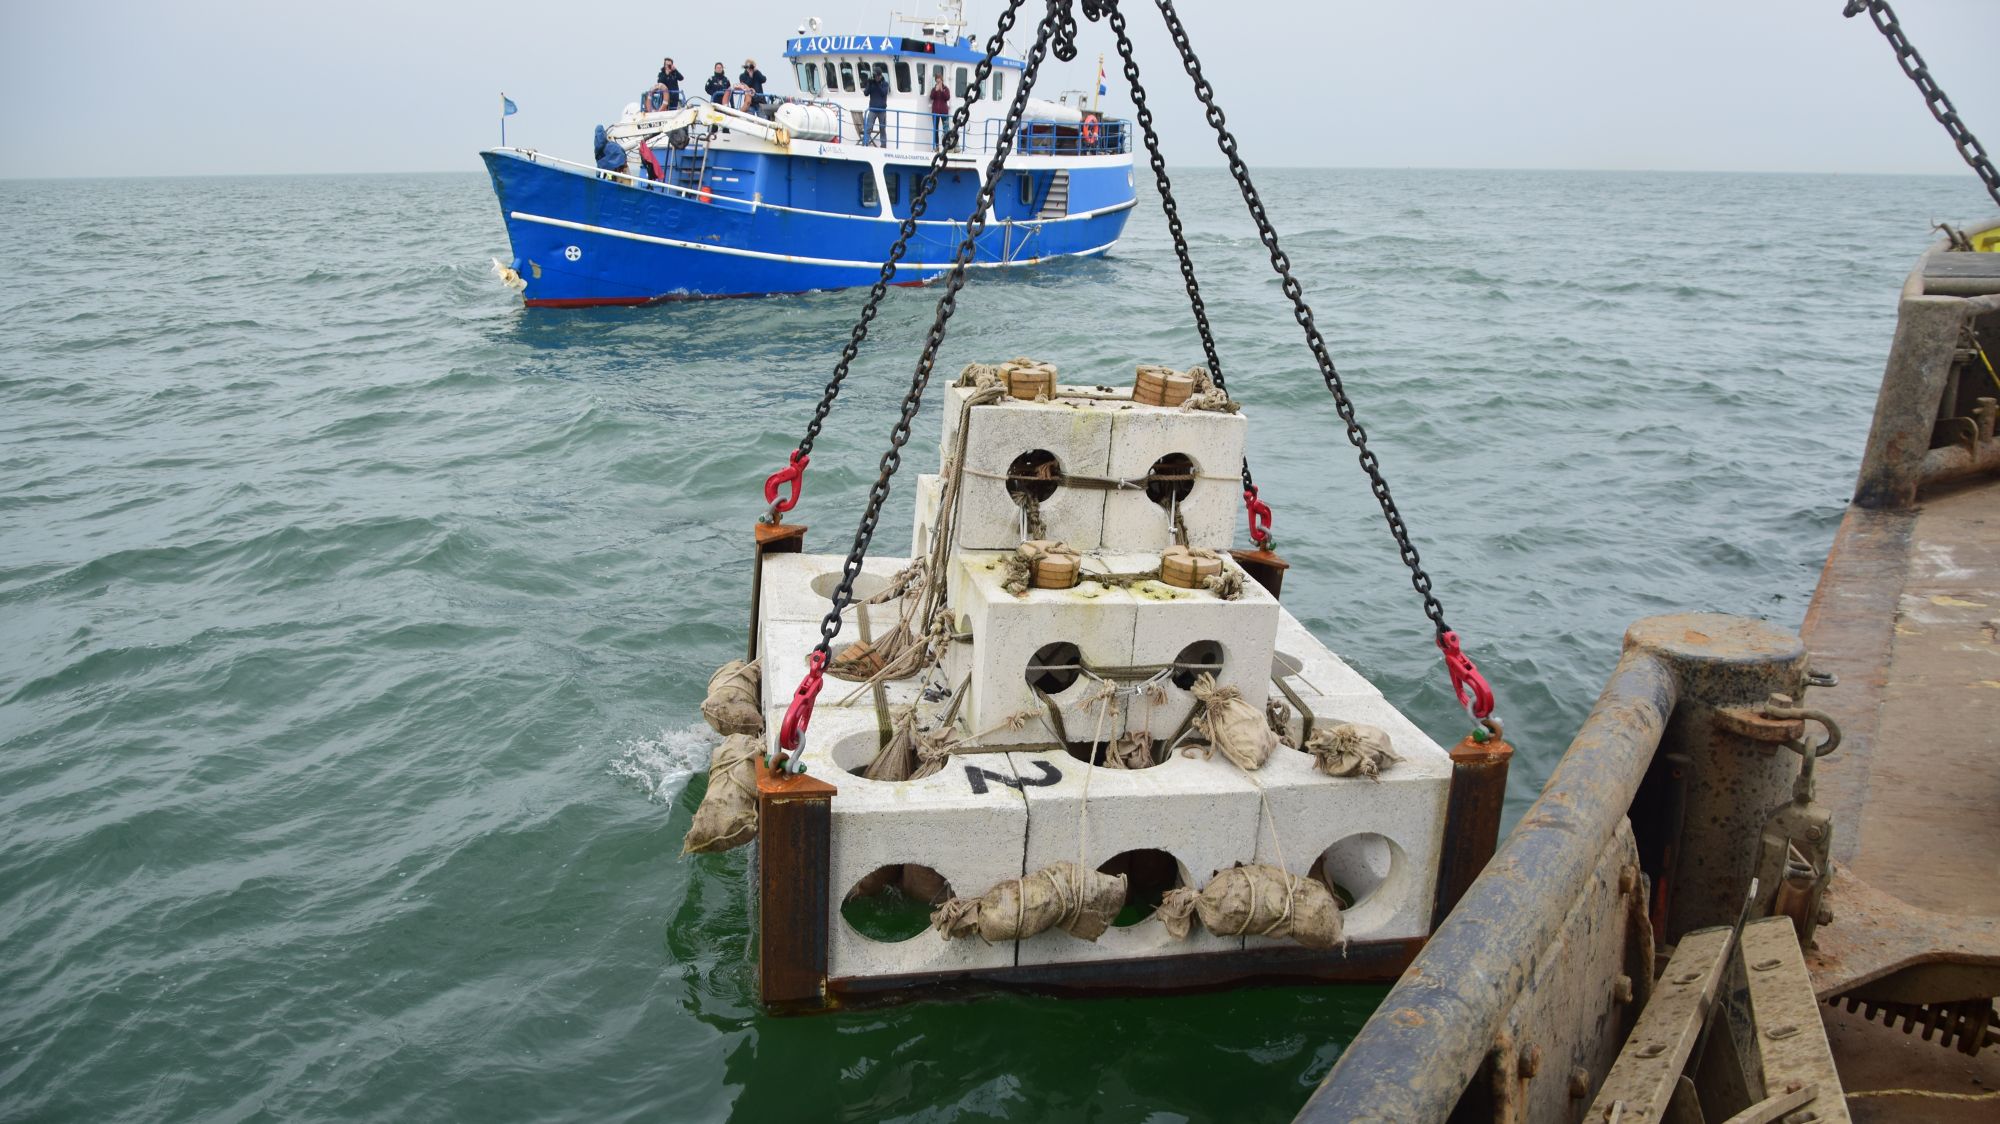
[948,552,1138,746]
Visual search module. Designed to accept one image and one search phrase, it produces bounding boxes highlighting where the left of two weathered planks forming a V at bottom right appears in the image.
[1584,926,1736,1124]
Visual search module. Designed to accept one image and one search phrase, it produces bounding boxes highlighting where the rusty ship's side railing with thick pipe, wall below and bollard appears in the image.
[1298,614,1810,1124]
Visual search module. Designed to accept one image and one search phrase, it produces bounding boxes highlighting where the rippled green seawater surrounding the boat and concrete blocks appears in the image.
[0,170,1990,1122]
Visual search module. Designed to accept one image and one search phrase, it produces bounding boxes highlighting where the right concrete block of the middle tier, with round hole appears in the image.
[1120,554,1282,738]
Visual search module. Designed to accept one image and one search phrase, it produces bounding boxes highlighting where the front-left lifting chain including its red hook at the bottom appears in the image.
[766,0,1076,772]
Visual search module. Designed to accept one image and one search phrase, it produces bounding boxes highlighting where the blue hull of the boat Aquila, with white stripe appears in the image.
[480,150,1132,308]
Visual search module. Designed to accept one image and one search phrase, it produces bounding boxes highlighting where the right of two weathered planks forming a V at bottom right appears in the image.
[1742,918,1848,1124]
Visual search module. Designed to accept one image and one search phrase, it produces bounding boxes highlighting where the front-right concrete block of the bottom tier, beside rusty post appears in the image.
[1248,694,1452,948]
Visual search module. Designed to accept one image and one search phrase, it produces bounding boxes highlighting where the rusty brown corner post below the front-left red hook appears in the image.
[756,760,836,1010]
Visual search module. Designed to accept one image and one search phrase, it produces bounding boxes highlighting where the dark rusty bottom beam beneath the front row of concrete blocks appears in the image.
[826,940,1424,1006]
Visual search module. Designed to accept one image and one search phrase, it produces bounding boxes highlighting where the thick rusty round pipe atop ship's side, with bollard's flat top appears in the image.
[1298,614,1806,1124]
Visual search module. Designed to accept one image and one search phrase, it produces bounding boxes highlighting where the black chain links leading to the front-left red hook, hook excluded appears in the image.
[814,0,1074,660]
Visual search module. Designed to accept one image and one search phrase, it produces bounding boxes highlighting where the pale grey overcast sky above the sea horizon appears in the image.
[0,0,2000,178]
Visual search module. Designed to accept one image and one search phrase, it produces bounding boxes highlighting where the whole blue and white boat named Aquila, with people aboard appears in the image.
[480,4,1134,308]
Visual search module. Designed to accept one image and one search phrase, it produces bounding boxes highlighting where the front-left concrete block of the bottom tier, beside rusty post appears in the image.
[806,712,1028,978]
